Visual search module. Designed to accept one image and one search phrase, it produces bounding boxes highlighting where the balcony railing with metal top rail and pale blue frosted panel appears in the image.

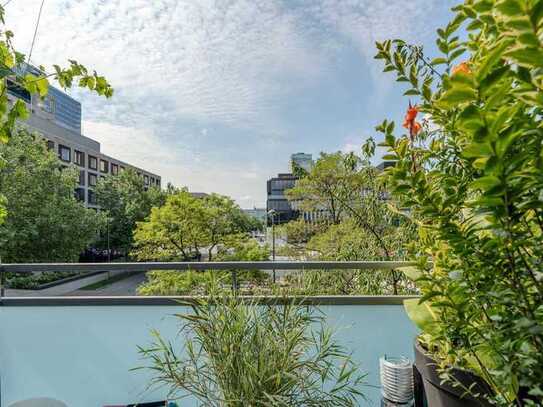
[0,261,416,407]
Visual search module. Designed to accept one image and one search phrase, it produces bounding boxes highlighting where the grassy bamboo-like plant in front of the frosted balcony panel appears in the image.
[140,296,363,407]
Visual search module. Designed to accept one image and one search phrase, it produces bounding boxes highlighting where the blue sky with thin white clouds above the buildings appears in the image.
[9,0,456,208]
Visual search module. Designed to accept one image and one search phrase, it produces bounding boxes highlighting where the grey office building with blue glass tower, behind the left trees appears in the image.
[8,67,162,208]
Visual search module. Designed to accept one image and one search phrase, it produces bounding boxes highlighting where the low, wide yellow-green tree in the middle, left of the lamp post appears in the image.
[133,191,253,261]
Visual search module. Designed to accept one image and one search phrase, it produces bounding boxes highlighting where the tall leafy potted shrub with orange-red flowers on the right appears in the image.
[376,0,543,407]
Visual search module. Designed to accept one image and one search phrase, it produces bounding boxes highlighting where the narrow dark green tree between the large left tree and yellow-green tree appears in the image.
[96,168,166,254]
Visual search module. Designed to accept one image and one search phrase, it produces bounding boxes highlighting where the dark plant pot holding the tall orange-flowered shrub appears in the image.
[415,341,492,407]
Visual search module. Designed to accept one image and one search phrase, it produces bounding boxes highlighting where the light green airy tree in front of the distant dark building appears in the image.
[283,150,414,294]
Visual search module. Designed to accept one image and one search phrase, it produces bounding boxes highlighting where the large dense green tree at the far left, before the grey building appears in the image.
[0,130,103,262]
